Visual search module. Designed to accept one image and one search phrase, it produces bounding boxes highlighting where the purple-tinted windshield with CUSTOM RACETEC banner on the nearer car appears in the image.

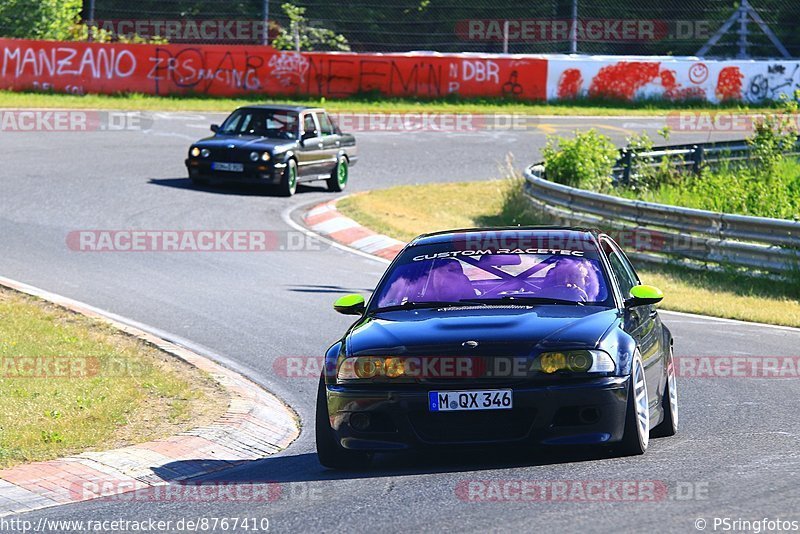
[371,239,613,310]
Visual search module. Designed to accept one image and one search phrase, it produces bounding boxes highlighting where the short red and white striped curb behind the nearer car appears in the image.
[303,198,406,260]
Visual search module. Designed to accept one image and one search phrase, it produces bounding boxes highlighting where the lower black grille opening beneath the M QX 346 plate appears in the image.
[408,408,536,443]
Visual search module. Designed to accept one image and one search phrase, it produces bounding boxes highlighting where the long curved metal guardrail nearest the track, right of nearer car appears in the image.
[525,164,800,274]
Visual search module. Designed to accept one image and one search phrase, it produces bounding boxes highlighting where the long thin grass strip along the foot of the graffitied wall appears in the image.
[0,91,788,116]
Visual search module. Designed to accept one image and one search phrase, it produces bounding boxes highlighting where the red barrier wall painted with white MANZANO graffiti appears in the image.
[0,39,547,100]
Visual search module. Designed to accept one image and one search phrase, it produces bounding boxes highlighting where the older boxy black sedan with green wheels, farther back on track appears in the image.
[186,106,358,196]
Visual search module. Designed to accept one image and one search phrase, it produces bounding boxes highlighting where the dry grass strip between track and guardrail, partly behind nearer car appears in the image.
[337,179,800,327]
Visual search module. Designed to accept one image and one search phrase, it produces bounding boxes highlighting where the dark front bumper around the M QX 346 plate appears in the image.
[327,377,629,451]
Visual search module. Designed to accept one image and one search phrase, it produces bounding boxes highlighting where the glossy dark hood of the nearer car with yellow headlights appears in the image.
[346,305,621,356]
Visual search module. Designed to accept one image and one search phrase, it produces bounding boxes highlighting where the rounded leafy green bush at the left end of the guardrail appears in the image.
[542,129,619,191]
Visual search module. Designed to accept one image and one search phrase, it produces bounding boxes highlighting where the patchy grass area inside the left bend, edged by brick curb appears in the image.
[0,288,228,468]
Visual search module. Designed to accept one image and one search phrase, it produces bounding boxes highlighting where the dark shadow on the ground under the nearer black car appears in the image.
[154,448,619,484]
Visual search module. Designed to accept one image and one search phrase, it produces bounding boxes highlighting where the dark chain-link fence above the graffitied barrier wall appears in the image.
[0,0,800,58]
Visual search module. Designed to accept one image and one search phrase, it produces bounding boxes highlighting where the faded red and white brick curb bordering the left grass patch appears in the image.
[0,277,300,517]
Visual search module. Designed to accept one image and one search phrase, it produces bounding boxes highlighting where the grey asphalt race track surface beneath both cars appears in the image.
[0,114,800,532]
